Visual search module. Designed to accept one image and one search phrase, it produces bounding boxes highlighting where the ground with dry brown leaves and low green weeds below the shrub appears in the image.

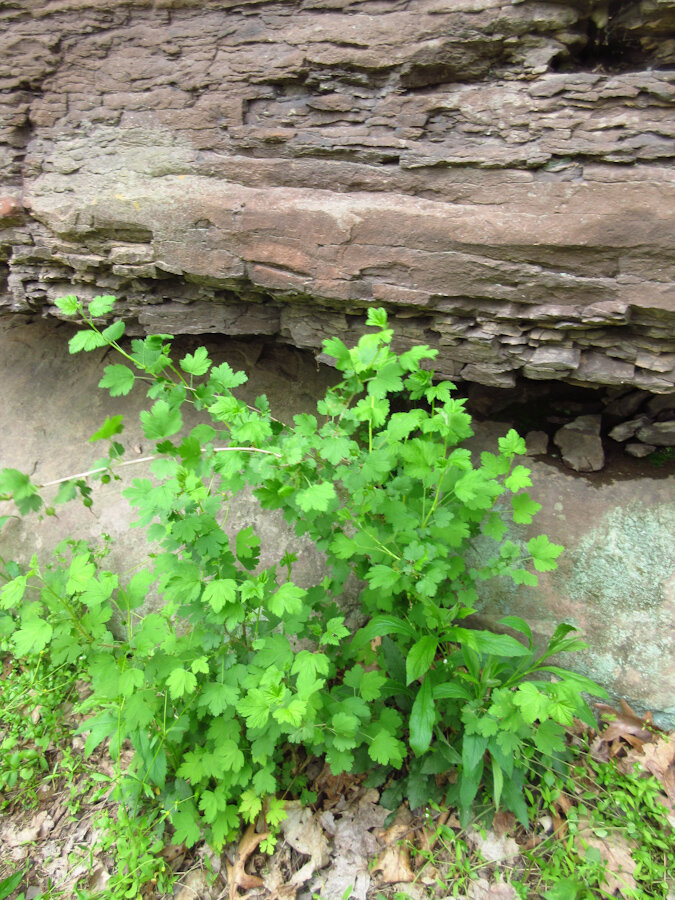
[0,656,675,900]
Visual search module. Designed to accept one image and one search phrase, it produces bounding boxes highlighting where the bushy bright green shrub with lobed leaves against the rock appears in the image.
[0,296,603,851]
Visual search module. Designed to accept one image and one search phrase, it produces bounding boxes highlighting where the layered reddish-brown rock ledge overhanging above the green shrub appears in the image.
[0,0,675,394]
